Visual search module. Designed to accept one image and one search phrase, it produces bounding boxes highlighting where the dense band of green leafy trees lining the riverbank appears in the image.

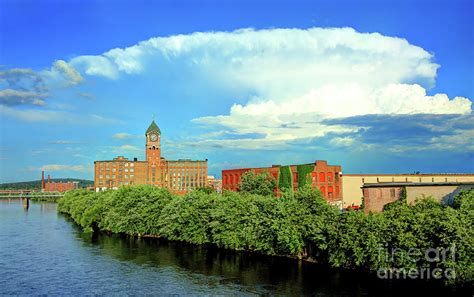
[58,186,474,286]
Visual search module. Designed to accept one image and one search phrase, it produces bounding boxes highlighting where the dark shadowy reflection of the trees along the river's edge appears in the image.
[68,219,462,296]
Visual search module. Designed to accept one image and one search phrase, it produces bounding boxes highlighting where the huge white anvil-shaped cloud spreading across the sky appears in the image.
[57,28,472,149]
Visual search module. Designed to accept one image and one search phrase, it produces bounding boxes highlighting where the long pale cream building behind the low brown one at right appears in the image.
[342,173,474,208]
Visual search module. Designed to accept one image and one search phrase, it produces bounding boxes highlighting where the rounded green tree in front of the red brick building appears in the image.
[239,171,276,196]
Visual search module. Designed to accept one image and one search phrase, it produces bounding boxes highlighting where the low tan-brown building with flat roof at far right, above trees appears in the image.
[362,182,474,213]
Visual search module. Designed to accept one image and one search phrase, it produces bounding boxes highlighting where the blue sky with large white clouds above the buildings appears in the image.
[0,0,474,182]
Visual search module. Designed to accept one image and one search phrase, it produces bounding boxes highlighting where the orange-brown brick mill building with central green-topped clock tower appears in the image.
[94,121,207,194]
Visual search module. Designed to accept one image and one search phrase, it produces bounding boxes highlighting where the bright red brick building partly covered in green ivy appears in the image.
[222,160,342,202]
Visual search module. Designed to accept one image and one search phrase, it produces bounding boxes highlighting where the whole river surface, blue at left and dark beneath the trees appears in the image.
[0,200,468,296]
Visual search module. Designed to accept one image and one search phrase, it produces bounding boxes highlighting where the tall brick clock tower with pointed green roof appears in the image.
[145,120,164,186]
